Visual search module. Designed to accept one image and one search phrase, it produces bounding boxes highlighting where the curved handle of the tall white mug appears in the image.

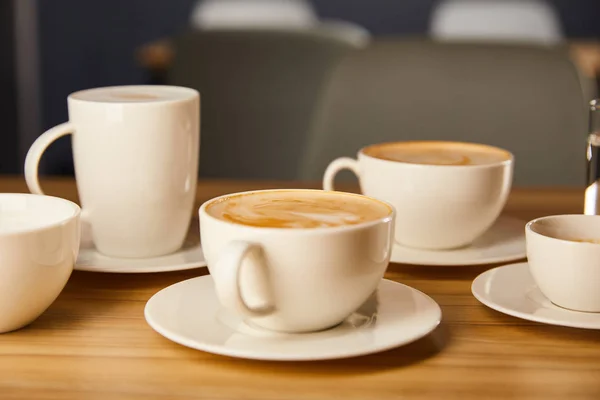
[25,122,75,194]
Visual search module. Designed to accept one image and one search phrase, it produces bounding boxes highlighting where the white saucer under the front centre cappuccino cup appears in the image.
[145,275,442,361]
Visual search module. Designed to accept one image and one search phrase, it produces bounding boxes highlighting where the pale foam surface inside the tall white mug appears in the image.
[70,85,196,103]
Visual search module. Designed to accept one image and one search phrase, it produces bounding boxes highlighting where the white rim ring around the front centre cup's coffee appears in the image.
[198,189,396,235]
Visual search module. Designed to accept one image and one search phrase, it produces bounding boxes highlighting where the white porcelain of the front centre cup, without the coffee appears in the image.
[199,190,395,332]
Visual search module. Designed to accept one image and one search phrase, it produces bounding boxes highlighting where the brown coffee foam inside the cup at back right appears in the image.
[363,141,512,166]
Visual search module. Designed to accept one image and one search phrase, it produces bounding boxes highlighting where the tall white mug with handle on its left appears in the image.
[25,86,200,258]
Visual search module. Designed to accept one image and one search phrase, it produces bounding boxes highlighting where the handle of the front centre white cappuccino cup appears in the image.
[215,240,275,317]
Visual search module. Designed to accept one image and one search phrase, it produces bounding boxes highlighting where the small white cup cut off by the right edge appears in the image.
[525,215,600,312]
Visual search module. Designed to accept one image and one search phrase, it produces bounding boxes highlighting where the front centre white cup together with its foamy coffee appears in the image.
[199,189,395,332]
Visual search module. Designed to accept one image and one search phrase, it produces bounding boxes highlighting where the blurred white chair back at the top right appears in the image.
[430,0,563,44]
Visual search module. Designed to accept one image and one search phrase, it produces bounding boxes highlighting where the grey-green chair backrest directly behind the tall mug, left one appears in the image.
[167,29,355,179]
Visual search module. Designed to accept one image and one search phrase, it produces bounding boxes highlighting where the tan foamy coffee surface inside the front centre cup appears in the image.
[206,190,392,228]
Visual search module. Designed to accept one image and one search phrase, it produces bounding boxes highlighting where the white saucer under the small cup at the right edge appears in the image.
[471,262,600,329]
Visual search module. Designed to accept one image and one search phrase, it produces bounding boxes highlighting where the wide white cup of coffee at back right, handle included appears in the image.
[323,141,513,250]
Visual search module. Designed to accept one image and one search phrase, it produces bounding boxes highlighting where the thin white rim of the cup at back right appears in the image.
[358,140,515,170]
